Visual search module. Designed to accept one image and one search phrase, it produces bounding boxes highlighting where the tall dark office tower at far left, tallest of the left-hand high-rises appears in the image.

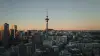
[3,23,10,49]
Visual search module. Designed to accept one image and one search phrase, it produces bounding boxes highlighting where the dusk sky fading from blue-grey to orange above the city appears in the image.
[0,0,100,30]
